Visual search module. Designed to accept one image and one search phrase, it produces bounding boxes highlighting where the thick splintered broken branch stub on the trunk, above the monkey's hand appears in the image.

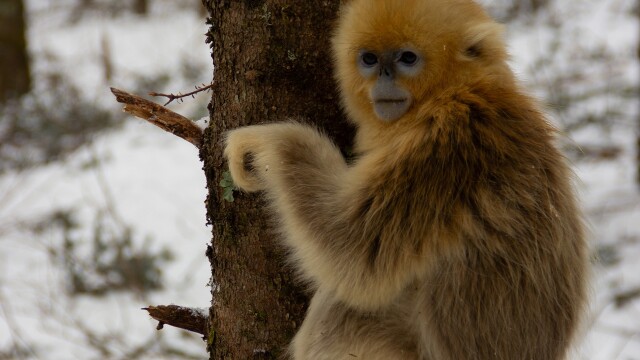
[111,88,202,149]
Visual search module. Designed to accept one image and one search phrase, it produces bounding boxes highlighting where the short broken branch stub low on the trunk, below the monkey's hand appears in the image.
[142,305,209,339]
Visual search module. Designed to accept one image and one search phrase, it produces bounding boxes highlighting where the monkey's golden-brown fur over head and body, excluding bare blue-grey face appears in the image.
[225,0,587,360]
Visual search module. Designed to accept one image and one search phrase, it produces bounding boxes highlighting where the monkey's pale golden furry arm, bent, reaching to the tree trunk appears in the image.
[225,124,427,309]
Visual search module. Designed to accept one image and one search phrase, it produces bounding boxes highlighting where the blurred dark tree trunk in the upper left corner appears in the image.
[0,0,31,103]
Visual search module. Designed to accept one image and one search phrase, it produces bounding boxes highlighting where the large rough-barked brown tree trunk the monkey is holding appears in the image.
[201,0,353,359]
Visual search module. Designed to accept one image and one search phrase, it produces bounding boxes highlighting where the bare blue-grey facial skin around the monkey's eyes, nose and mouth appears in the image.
[357,49,424,121]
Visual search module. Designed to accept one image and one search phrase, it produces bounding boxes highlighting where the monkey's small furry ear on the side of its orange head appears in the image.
[462,22,505,59]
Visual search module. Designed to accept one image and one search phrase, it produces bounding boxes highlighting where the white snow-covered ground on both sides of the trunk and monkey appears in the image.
[0,0,640,360]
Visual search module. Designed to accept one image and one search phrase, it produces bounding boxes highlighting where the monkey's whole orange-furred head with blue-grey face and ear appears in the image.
[333,0,505,126]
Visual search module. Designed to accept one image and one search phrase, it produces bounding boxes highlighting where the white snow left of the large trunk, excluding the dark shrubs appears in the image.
[0,0,212,359]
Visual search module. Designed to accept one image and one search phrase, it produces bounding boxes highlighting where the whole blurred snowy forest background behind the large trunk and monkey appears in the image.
[0,0,640,360]
